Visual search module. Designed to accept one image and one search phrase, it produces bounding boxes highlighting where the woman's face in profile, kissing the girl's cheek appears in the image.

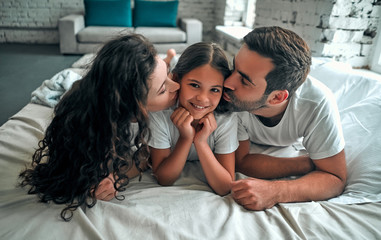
[147,56,180,112]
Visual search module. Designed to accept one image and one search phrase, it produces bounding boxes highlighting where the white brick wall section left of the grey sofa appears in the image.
[0,0,84,43]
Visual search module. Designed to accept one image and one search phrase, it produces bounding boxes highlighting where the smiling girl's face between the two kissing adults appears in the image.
[179,64,224,120]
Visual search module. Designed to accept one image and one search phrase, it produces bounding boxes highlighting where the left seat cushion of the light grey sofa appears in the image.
[77,26,134,43]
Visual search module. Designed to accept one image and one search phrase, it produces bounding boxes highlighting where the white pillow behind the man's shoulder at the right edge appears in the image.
[310,59,381,203]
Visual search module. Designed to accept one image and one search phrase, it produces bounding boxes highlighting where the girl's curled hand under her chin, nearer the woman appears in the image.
[171,107,195,141]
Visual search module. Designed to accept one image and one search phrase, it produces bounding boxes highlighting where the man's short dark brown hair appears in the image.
[243,27,311,97]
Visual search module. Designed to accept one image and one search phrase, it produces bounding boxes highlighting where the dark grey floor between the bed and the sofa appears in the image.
[0,44,81,126]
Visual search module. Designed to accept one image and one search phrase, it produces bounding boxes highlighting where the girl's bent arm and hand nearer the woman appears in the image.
[151,108,195,186]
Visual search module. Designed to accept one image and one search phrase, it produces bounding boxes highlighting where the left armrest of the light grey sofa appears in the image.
[58,14,85,54]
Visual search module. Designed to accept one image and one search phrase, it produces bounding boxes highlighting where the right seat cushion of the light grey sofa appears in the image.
[135,27,187,43]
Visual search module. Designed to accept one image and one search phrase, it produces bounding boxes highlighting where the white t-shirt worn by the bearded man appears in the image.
[238,76,345,159]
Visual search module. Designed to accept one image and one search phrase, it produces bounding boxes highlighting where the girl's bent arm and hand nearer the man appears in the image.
[194,113,235,196]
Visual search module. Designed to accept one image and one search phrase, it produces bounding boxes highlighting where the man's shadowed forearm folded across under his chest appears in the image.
[236,140,315,179]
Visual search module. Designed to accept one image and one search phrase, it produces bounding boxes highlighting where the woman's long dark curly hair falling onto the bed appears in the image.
[20,34,157,221]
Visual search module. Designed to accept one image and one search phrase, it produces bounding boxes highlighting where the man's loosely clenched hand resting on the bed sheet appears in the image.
[231,178,278,211]
